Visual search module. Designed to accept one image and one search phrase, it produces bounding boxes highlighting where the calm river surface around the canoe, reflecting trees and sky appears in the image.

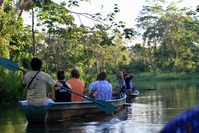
[0,81,199,133]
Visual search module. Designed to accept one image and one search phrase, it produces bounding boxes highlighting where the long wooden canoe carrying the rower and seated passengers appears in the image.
[19,96,126,123]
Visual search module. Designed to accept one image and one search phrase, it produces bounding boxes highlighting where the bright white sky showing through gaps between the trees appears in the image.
[23,0,199,44]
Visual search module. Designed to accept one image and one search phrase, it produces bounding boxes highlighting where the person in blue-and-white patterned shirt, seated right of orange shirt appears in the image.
[88,72,112,100]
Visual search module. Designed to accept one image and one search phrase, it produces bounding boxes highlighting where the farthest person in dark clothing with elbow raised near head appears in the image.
[124,73,134,94]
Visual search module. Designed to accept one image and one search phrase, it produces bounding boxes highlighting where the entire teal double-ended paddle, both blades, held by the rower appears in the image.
[0,58,115,113]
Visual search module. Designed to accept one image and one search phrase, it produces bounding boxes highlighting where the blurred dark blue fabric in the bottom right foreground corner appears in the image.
[160,105,199,133]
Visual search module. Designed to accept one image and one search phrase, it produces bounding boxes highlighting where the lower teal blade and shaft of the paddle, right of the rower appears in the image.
[59,86,115,113]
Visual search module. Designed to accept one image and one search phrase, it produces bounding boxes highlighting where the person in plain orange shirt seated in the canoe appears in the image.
[66,68,85,102]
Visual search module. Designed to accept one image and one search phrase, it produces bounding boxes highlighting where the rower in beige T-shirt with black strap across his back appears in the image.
[22,58,56,106]
